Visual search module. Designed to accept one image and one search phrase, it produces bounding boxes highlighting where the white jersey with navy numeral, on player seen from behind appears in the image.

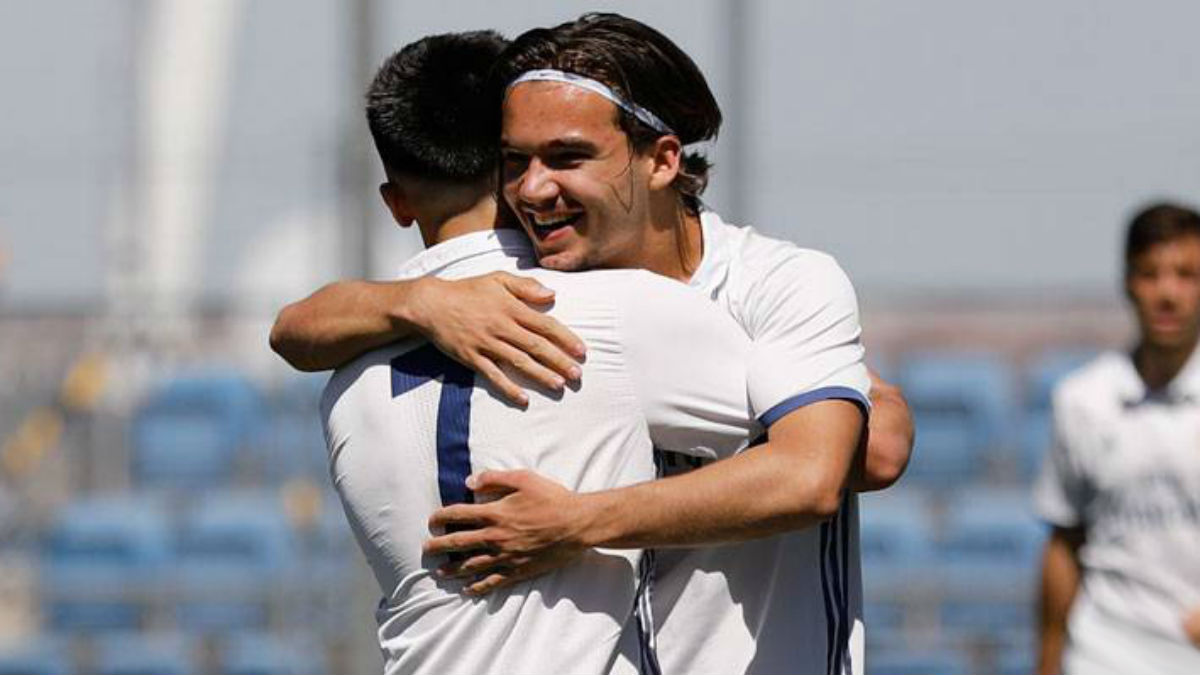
[322,231,761,675]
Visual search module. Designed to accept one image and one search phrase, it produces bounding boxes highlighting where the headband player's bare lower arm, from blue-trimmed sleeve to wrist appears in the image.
[580,401,862,548]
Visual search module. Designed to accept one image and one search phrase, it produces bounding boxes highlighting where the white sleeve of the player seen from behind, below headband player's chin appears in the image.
[620,273,760,459]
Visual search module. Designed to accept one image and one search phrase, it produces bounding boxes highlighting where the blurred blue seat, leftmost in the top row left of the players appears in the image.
[131,371,262,489]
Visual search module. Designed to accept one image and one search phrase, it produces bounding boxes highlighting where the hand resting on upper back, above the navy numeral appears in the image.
[413,271,584,405]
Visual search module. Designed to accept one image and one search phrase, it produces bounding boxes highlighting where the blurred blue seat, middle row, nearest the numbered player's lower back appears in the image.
[175,491,298,631]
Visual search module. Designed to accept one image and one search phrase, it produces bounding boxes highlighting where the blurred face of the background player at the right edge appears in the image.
[1126,235,1200,350]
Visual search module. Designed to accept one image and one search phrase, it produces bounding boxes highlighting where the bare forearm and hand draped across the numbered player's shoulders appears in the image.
[270,273,583,402]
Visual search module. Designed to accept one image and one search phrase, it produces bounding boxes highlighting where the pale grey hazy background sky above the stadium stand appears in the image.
[0,0,1200,312]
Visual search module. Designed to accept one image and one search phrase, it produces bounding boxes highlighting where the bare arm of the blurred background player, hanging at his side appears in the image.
[1038,527,1084,675]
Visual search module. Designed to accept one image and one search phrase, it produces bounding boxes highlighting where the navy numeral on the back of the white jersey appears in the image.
[391,345,475,506]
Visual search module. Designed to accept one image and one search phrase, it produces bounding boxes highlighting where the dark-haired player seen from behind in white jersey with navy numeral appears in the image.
[322,32,763,675]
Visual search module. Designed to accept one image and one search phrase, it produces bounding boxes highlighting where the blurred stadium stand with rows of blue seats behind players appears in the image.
[0,302,1118,675]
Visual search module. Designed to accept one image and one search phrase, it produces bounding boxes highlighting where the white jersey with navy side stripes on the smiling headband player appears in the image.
[653,211,870,675]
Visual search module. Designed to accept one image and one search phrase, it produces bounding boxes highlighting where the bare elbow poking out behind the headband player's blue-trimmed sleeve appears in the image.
[851,370,914,492]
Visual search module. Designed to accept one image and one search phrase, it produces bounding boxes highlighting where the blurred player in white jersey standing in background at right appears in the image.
[1034,204,1200,675]
